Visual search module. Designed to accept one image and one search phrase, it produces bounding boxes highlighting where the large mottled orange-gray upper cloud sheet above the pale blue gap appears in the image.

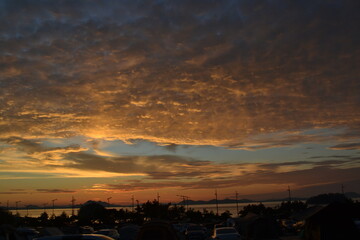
[0,0,360,146]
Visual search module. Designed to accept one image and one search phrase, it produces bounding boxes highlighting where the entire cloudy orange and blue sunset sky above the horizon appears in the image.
[0,0,360,206]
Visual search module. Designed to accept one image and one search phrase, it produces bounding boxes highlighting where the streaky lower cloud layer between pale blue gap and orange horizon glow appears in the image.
[1,138,360,193]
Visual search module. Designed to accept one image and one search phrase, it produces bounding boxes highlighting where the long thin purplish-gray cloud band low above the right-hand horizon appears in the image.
[99,167,359,191]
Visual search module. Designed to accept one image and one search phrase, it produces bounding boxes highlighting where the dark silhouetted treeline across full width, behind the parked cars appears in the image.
[0,194,359,227]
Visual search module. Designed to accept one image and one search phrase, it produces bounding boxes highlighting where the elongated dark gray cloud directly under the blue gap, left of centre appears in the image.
[61,153,225,179]
